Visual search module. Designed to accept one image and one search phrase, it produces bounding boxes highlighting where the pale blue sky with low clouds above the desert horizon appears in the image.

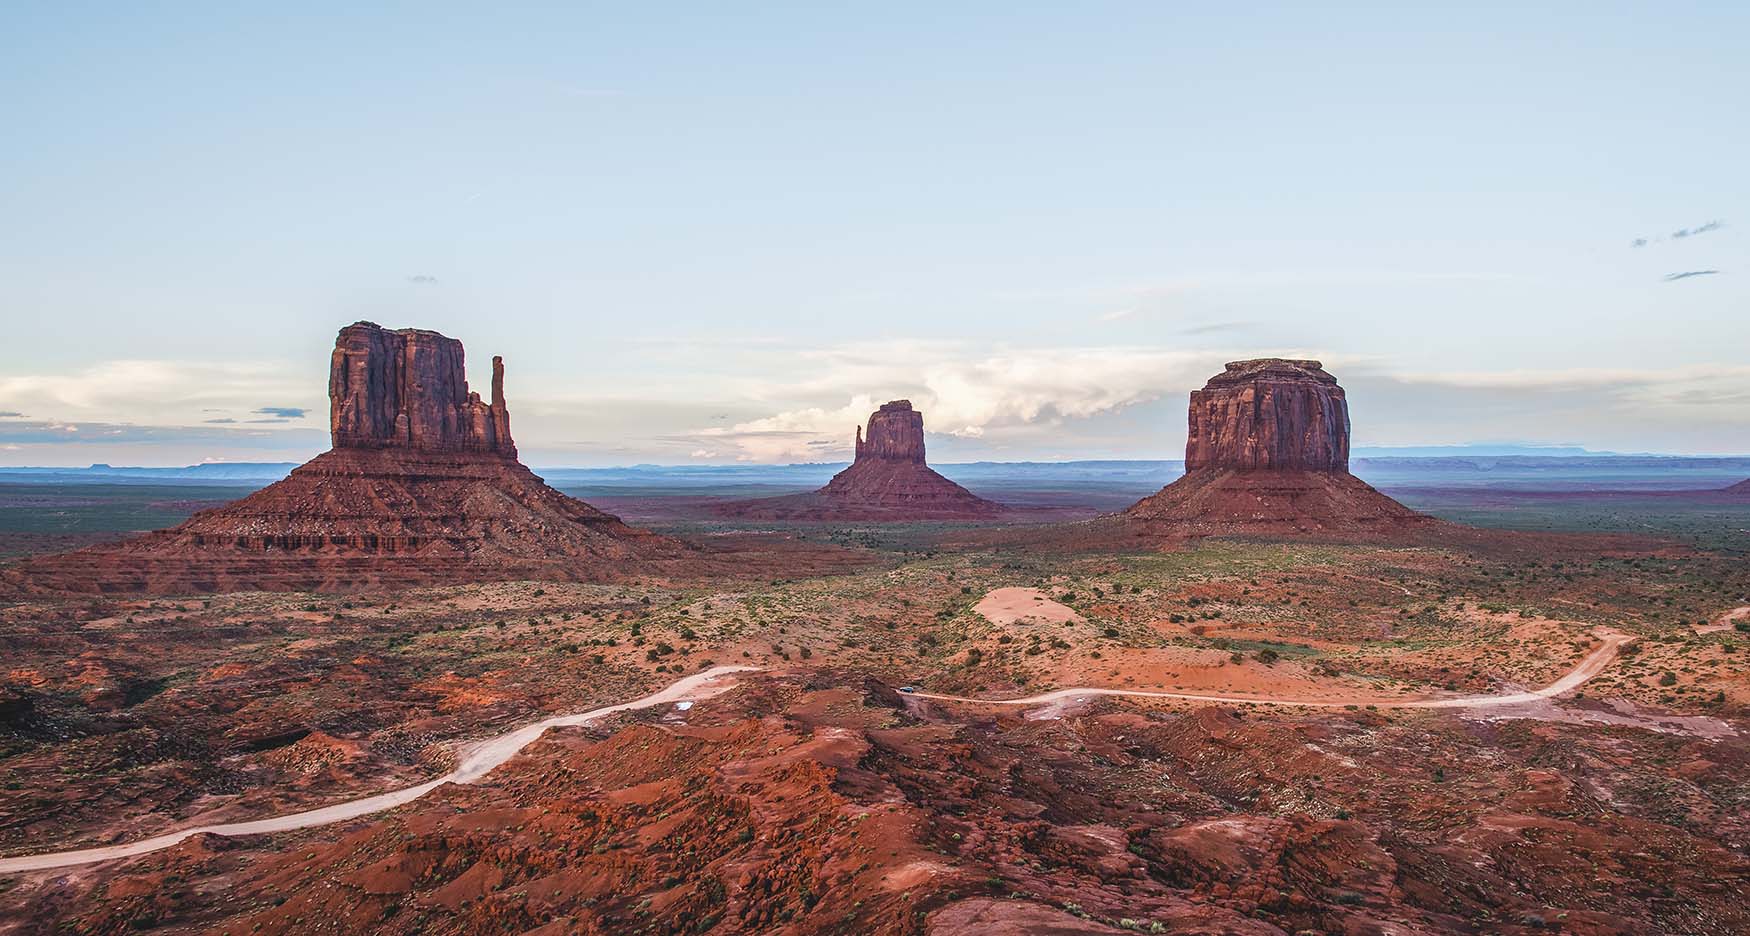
[0,0,1750,465]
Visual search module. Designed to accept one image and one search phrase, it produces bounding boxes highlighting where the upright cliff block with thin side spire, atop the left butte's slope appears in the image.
[329,322,516,458]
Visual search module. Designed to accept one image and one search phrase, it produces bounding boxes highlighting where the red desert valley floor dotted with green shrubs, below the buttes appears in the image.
[0,514,1750,934]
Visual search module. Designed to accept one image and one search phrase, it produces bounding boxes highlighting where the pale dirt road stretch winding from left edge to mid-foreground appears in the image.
[0,667,758,875]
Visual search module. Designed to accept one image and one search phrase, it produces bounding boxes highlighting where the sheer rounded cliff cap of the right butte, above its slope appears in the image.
[1185,357,1349,472]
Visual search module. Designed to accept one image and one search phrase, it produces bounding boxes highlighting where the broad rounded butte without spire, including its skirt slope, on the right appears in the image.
[1122,357,1433,535]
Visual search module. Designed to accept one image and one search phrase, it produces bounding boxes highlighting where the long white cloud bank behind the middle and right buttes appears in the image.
[676,341,1750,462]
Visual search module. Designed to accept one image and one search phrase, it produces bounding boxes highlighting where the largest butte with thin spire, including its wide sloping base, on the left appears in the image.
[0,322,691,593]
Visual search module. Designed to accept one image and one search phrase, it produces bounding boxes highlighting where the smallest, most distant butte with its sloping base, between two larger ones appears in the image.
[716,399,1006,521]
